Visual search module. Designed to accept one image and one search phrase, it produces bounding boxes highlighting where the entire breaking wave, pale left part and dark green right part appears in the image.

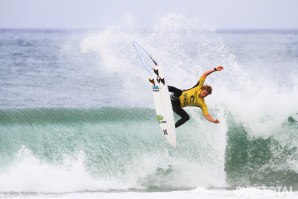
[0,108,298,192]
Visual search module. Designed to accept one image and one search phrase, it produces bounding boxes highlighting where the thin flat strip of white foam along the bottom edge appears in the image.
[3,188,298,199]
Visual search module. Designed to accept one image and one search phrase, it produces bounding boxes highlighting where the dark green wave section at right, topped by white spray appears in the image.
[225,113,298,190]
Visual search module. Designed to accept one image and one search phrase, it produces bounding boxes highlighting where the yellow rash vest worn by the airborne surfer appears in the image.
[179,76,209,116]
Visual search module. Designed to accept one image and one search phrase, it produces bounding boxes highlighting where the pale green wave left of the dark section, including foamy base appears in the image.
[0,108,224,192]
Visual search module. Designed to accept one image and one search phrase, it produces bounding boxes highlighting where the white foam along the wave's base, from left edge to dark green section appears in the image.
[0,147,225,193]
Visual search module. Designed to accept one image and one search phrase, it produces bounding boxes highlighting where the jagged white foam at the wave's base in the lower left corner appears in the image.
[0,147,129,193]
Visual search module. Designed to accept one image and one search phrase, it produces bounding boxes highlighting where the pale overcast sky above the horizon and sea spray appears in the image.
[0,0,298,29]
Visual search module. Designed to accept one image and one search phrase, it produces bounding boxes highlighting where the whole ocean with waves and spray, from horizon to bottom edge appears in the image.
[0,16,298,199]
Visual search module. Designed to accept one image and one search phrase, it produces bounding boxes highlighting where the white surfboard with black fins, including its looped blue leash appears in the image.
[133,41,176,147]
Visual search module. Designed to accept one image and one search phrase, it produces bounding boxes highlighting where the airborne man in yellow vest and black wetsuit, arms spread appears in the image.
[168,66,223,128]
